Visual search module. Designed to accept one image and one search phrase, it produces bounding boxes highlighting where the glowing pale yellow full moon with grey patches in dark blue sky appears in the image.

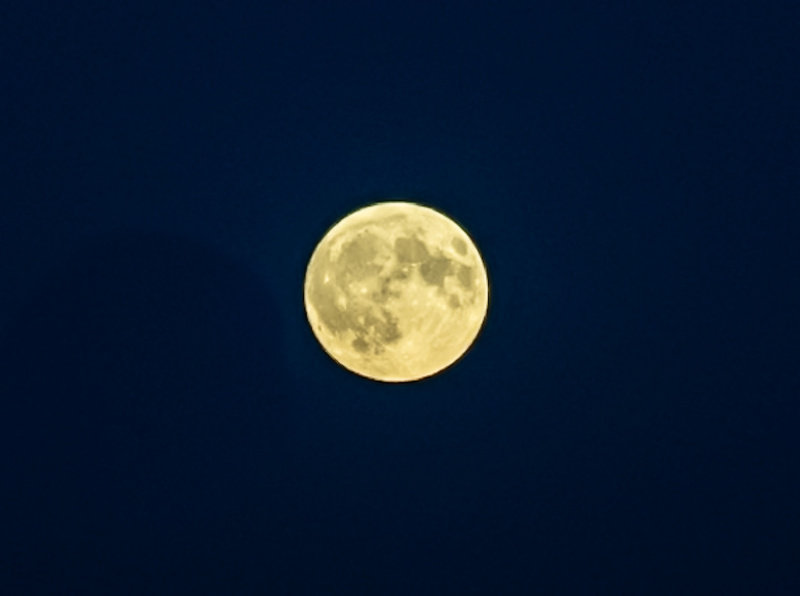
[305,201,489,382]
